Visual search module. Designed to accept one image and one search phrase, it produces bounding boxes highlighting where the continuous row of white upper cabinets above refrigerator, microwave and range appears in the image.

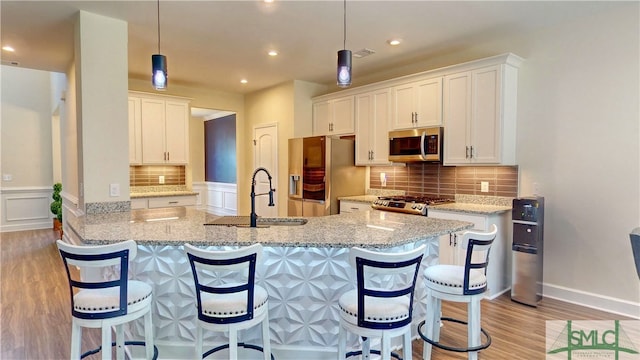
[313,53,523,165]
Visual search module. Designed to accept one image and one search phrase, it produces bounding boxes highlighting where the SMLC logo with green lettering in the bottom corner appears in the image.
[546,320,640,360]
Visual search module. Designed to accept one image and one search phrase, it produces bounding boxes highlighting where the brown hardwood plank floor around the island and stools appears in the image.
[0,230,623,360]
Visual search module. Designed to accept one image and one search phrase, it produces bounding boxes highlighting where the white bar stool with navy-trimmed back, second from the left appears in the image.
[184,243,273,360]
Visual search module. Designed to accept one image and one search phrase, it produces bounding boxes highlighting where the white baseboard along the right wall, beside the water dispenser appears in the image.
[543,283,640,319]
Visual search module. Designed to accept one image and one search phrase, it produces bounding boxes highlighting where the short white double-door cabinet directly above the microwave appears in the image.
[392,77,442,130]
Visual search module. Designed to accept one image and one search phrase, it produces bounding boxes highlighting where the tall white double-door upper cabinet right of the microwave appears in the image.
[444,64,517,165]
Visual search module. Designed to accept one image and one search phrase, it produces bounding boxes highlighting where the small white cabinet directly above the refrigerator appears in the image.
[313,95,355,136]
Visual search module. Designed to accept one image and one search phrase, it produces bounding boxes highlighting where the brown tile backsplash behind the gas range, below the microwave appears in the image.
[369,163,518,198]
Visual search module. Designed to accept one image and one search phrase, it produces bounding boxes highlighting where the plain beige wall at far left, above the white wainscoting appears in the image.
[0,65,53,188]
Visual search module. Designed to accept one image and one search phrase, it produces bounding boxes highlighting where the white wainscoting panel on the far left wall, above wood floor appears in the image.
[0,187,53,232]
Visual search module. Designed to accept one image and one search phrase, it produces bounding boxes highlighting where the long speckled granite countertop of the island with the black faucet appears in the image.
[67,207,473,248]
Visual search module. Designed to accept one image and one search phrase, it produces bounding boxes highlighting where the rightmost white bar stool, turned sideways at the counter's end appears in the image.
[418,224,498,360]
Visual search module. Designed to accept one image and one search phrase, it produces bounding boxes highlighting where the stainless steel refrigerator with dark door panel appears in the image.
[287,136,365,217]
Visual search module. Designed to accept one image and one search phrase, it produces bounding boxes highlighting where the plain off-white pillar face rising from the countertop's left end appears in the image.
[75,11,129,204]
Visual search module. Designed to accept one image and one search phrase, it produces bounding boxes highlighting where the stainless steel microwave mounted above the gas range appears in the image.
[389,127,444,162]
